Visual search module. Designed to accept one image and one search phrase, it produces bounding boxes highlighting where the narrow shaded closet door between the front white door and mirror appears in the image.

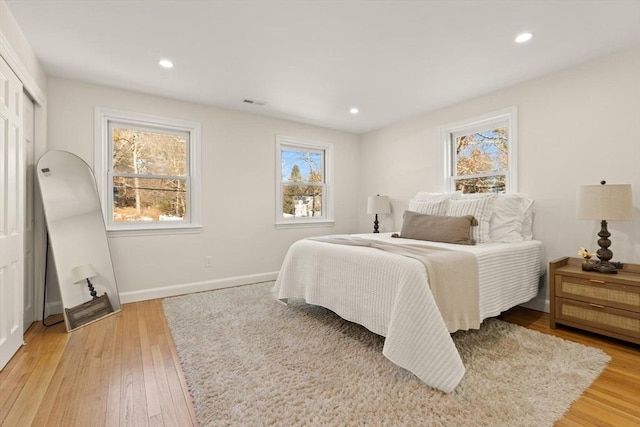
[22,94,37,332]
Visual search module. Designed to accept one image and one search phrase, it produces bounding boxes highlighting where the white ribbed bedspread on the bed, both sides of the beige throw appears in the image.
[273,234,541,393]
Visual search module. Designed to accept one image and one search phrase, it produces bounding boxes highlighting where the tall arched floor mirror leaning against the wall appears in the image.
[36,151,121,331]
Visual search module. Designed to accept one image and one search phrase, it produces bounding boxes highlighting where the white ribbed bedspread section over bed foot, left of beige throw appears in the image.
[273,239,480,393]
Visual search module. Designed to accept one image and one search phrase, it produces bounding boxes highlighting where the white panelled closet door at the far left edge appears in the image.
[0,58,25,369]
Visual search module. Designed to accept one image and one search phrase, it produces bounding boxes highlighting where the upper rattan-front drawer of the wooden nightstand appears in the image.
[555,275,640,312]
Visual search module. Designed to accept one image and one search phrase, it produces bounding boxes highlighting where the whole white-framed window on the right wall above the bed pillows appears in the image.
[440,107,517,193]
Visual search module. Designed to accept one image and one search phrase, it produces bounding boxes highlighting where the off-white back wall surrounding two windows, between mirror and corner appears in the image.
[48,78,359,302]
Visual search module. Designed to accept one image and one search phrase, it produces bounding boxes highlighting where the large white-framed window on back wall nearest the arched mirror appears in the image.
[95,109,200,232]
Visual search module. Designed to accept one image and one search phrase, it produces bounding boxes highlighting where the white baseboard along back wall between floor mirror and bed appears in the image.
[120,271,278,304]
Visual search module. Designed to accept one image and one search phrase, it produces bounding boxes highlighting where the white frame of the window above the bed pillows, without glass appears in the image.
[439,106,518,193]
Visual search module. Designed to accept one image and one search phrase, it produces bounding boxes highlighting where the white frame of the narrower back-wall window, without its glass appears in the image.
[275,135,335,228]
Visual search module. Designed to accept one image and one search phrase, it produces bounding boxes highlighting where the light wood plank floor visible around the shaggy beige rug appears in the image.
[0,300,640,427]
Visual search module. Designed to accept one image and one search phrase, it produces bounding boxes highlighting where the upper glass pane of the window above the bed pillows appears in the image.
[454,127,509,176]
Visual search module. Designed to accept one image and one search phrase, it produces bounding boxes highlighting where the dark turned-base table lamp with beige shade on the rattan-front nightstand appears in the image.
[577,181,633,273]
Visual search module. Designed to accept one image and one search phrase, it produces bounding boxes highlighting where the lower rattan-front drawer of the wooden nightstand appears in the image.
[555,298,640,343]
